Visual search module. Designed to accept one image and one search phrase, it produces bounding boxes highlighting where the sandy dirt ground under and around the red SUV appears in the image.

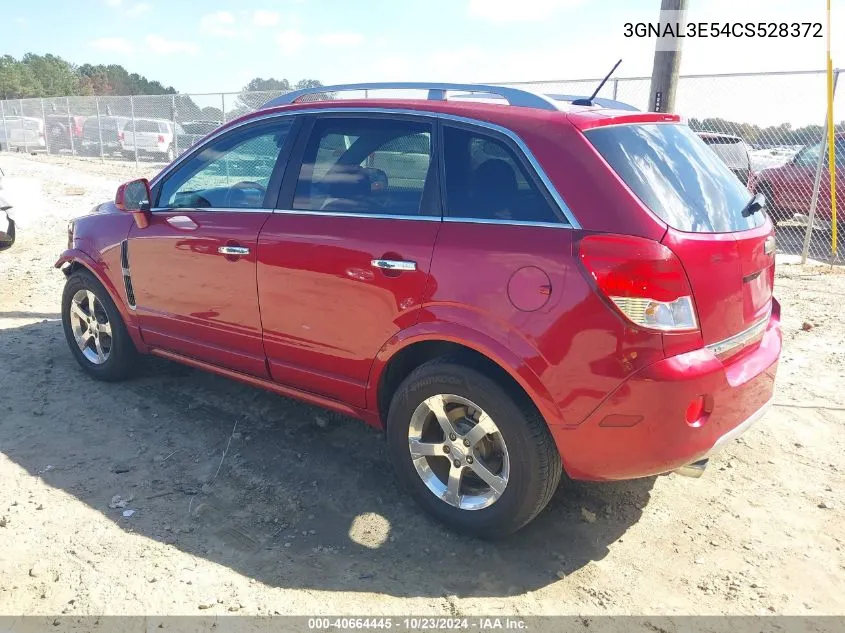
[0,154,845,616]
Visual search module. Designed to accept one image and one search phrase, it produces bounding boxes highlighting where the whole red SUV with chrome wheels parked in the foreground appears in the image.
[56,84,781,536]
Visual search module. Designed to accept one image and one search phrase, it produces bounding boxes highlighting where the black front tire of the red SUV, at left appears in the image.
[62,270,138,382]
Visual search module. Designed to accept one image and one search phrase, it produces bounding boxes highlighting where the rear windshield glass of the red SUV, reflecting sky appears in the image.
[585,123,766,233]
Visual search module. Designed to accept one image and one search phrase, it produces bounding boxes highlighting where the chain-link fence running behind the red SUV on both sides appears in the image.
[0,71,845,261]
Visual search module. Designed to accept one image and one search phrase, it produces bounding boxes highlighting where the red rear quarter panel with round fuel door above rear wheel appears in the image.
[380,222,663,426]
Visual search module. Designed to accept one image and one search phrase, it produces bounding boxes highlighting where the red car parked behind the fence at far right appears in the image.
[749,132,845,228]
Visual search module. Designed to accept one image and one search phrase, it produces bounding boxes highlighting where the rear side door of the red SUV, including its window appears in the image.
[258,114,441,406]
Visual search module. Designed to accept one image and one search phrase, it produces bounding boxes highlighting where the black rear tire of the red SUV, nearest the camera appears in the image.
[387,357,562,538]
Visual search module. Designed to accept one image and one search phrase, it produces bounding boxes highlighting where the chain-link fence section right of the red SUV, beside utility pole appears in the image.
[502,70,845,261]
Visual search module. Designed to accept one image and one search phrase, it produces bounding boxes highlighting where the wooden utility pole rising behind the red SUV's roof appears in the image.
[648,0,687,112]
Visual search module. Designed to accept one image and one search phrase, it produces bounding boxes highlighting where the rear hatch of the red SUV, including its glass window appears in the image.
[585,123,775,355]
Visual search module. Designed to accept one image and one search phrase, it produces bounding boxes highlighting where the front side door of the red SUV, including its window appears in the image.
[127,117,291,377]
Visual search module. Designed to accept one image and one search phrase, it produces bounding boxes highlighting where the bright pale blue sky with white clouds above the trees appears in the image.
[0,0,845,123]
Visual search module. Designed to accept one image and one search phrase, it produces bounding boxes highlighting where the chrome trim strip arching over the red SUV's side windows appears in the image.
[150,106,581,229]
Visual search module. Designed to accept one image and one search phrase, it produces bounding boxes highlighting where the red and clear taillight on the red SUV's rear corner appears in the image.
[579,235,698,332]
